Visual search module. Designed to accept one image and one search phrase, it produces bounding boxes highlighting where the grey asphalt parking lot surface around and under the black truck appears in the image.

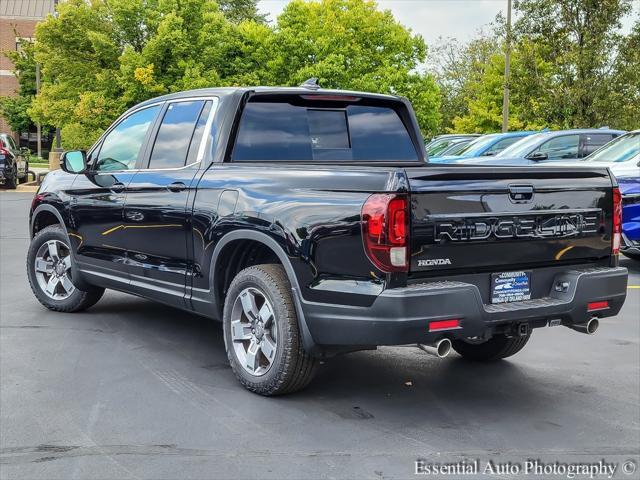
[0,193,640,479]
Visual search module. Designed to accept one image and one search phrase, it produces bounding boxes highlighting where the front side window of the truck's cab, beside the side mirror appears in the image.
[94,105,160,171]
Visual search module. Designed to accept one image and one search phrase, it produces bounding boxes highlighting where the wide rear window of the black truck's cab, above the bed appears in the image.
[232,101,418,161]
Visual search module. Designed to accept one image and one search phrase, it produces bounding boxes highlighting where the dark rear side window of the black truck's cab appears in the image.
[149,100,211,169]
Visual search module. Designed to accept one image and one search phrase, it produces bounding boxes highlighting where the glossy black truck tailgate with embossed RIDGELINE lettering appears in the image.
[406,165,613,273]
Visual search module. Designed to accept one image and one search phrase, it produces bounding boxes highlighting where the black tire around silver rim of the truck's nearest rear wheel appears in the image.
[223,264,318,396]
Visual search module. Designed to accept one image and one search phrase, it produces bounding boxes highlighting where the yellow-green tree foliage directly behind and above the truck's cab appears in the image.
[30,0,439,147]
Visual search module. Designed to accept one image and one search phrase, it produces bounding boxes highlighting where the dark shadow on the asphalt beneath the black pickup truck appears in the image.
[87,288,570,423]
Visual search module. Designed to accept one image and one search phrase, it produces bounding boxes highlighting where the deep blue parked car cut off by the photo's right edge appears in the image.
[583,130,640,260]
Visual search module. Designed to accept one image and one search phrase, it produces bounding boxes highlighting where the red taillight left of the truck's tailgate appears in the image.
[362,194,409,272]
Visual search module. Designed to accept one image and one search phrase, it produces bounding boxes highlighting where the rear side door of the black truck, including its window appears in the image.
[123,98,214,306]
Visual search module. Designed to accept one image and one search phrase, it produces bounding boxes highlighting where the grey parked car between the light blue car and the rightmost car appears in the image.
[452,128,625,165]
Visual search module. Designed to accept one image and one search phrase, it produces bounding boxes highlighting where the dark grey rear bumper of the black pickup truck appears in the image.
[300,267,627,346]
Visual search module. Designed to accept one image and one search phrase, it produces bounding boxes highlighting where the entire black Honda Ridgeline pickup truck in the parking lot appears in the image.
[27,86,627,395]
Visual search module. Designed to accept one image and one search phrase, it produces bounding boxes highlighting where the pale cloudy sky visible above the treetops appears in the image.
[258,0,640,45]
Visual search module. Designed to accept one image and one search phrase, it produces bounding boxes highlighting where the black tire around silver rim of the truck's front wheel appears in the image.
[27,225,104,313]
